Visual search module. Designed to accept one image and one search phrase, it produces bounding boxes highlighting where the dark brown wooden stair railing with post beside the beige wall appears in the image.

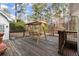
[58,31,78,55]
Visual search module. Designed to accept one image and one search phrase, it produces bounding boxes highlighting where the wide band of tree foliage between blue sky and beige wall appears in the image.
[31,3,69,21]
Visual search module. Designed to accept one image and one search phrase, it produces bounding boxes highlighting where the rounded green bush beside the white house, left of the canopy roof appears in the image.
[10,20,25,31]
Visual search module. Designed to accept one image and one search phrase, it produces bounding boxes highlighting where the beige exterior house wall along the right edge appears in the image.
[70,3,79,54]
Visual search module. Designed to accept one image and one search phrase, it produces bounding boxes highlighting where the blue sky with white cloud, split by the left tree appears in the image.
[0,3,32,15]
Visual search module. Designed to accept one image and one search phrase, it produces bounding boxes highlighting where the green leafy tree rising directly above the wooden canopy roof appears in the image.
[32,3,46,20]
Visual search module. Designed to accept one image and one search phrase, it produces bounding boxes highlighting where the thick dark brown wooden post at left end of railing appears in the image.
[58,31,67,54]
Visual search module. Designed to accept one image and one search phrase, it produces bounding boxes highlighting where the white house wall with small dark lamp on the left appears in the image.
[0,14,9,40]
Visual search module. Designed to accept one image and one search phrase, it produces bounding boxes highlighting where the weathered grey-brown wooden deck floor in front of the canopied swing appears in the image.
[2,37,59,56]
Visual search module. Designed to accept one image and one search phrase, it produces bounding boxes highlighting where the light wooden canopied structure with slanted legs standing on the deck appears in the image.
[26,21,47,43]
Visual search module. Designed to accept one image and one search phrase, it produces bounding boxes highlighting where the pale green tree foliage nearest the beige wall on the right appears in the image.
[52,3,69,28]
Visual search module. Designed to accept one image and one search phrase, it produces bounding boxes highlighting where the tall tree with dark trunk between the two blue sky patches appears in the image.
[15,3,27,20]
